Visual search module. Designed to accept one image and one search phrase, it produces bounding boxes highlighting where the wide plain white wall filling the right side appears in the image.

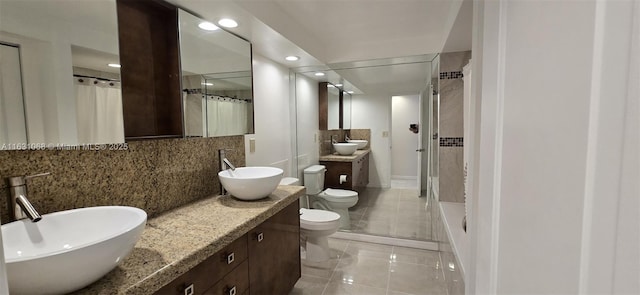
[465,0,640,294]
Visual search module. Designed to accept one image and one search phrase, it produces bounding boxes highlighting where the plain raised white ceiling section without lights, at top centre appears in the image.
[236,0,471,63]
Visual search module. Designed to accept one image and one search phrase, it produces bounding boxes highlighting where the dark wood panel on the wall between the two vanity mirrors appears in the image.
[116,0,183,140]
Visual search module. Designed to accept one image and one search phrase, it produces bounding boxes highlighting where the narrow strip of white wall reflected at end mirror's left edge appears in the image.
[295,75,320,179]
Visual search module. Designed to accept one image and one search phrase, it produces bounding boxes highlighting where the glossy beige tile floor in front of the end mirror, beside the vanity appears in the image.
[290,238,447,295]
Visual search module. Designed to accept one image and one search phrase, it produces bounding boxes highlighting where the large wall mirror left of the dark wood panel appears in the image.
[0,0,124,149]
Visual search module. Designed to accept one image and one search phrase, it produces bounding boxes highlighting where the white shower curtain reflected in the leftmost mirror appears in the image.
[74,78,124,144]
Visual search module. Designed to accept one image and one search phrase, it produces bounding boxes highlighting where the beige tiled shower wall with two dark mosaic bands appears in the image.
[439,51,471,202]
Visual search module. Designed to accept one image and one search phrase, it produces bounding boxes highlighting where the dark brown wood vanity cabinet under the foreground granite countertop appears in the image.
[155,201,300,295]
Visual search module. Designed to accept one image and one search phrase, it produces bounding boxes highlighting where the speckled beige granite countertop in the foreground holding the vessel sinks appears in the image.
[72,186,304,295]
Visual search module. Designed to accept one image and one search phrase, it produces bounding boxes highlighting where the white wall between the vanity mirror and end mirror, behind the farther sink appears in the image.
[245,53,295,176]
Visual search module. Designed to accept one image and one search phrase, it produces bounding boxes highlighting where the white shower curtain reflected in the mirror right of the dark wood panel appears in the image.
[206,95,250,137]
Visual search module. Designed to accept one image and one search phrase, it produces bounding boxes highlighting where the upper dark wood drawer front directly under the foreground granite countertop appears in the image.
[155,235,247,295]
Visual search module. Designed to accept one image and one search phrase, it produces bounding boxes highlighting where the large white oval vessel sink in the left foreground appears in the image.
[2,206,147,294]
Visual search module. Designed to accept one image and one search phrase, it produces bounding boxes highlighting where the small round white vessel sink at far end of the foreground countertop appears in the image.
[218,167,284,201]
